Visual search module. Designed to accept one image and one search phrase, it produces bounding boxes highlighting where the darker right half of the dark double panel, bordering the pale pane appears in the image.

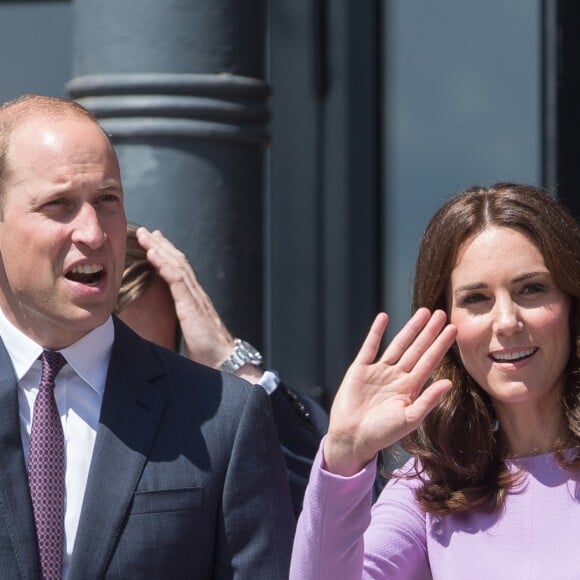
[321,0,380,399]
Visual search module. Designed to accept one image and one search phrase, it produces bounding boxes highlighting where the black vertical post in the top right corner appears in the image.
[543,0,580,219]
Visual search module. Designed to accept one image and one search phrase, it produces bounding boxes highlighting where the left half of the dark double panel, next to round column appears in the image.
[265,0,321,392]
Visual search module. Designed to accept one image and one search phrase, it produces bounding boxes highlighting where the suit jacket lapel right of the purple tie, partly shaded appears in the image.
[69,320,166,580]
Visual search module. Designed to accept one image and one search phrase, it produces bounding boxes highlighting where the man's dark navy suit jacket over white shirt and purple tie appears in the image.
[0,319,294,580]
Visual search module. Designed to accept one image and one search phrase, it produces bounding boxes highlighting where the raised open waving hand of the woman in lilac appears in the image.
[324,308,457,476]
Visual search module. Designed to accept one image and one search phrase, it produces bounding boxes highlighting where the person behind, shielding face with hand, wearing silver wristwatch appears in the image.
[116,224,328,516]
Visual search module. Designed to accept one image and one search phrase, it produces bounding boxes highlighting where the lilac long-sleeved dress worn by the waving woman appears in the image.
[290,446,580,580]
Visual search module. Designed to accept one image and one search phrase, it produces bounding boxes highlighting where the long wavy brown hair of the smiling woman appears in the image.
[401,183,580,515]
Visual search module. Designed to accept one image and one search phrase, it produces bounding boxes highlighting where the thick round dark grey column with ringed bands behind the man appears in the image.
[68,0,269,345]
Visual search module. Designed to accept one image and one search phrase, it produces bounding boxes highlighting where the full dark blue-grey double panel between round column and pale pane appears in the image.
[268,0,379,399]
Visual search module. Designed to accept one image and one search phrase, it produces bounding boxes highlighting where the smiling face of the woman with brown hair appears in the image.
[448,226,570,405]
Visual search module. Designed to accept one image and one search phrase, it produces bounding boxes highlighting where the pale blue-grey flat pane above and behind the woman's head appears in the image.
[383,0,541,334]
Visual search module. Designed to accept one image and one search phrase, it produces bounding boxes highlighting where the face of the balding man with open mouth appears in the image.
[0,116,126,349]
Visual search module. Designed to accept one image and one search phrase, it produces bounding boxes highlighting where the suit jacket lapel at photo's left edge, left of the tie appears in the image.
[0,339,40,578]
